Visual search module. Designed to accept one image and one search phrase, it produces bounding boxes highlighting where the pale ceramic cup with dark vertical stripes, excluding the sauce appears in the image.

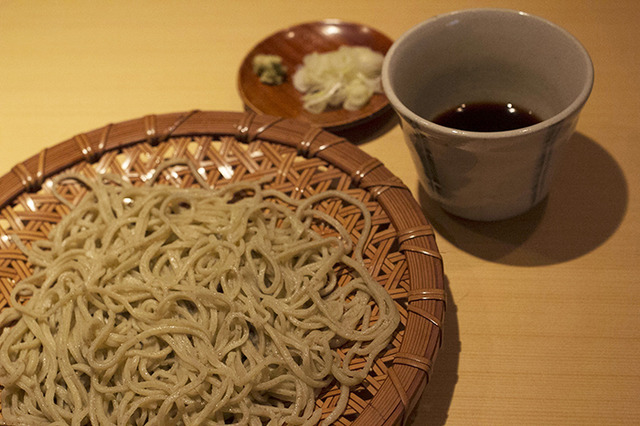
[382,9,593,221]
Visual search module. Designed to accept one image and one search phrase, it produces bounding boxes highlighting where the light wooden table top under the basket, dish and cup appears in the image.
[0,0,640,426]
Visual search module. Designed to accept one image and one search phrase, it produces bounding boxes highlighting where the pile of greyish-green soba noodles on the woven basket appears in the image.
[0,167,399,426]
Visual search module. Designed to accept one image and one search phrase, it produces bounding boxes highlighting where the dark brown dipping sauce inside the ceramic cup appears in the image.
[432,102,542,132]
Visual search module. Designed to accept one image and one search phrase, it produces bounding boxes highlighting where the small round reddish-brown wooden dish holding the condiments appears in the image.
[238,19,393,131]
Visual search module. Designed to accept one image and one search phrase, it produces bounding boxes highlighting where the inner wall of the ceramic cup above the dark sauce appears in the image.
[383,9,593,128]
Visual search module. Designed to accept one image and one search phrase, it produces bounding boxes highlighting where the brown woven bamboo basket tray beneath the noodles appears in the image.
[0,111,445,426]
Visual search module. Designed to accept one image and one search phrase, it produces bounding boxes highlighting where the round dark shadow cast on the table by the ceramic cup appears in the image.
[418,133,628,266]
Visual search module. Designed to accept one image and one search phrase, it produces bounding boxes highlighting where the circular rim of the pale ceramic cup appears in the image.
[381,8,594,142]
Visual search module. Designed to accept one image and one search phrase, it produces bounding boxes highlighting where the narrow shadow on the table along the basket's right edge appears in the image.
[407,277,461,426]
